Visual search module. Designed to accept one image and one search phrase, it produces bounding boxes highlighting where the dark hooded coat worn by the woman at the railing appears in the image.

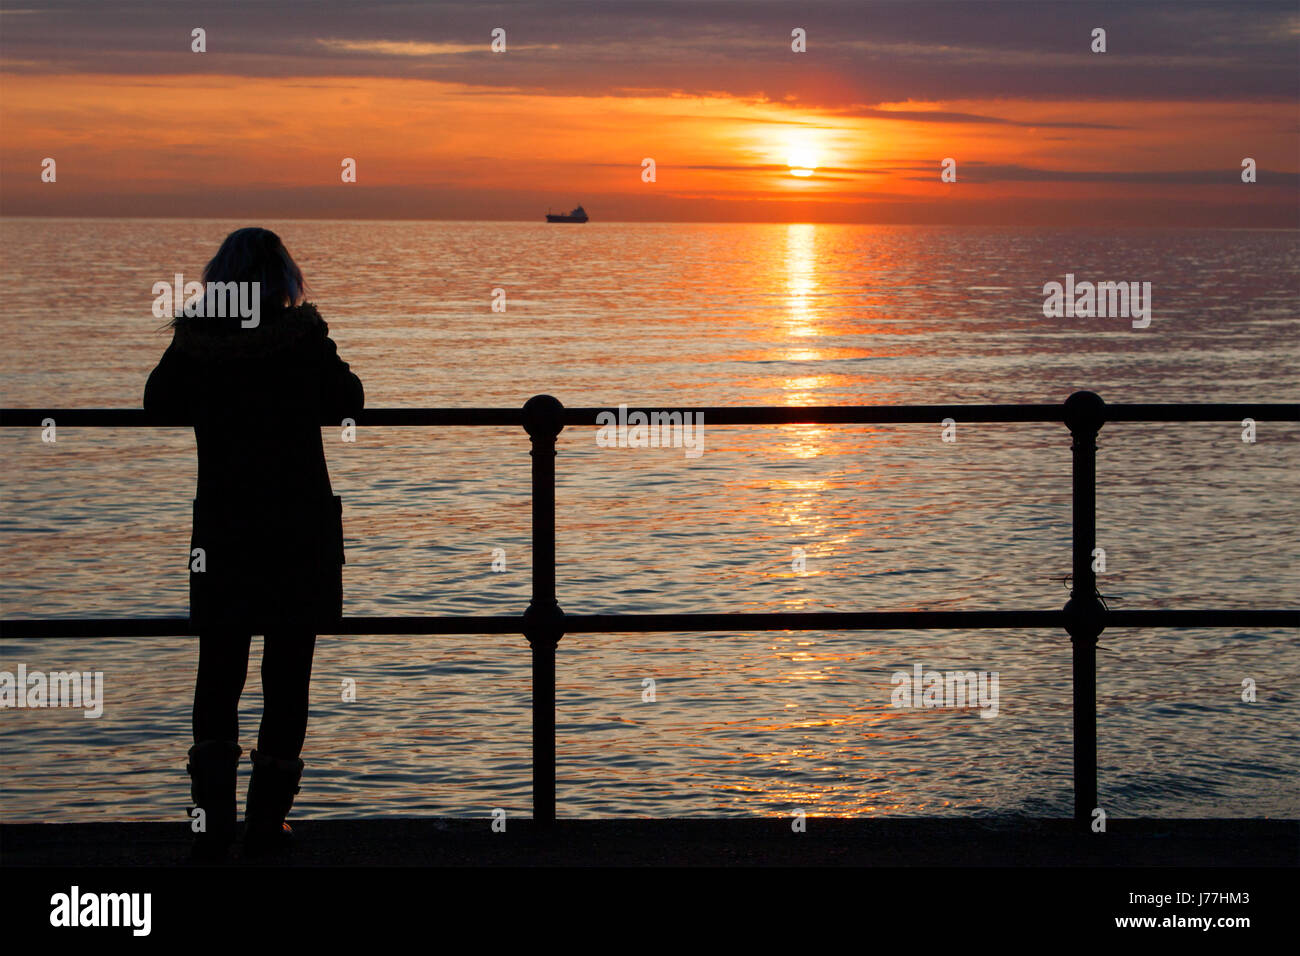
[144,303,364,633]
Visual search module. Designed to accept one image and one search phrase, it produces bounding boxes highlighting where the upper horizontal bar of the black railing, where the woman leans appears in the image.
[0,402,1300,427]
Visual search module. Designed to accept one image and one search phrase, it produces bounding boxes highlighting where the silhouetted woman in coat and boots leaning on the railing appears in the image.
[144,229,364,858]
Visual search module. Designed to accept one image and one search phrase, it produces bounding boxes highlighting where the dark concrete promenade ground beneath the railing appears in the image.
[0,817,1300,868]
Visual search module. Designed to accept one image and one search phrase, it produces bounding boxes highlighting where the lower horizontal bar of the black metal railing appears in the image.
[0,609,1300,639]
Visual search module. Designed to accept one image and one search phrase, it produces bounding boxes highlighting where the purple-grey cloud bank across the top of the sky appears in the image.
[0,0,1300,105]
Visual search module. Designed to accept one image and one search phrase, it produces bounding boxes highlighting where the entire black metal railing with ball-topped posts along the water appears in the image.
[0,392,1300,827]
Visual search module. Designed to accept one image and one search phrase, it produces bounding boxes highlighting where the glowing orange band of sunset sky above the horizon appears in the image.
[0,0,1300,228]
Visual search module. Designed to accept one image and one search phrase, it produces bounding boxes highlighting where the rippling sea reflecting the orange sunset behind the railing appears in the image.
[0,218,1300,825]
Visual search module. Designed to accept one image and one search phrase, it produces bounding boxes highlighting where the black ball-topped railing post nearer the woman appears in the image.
[524,395,564,830]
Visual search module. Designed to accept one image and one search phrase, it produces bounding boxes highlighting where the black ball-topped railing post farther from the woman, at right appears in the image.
[1065,392,1106,831]
